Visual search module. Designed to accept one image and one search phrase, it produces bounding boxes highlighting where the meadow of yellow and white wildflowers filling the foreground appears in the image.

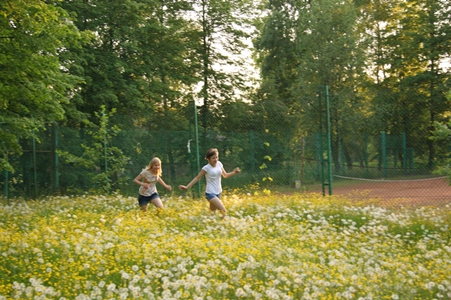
[0,194,451,299]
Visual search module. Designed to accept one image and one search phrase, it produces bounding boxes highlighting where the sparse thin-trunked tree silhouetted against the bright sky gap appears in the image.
[193,0,253,129]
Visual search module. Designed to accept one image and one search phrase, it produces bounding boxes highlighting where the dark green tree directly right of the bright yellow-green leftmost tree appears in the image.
[61,0,153,124]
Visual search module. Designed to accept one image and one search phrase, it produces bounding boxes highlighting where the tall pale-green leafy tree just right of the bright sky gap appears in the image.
[257,0,368,167]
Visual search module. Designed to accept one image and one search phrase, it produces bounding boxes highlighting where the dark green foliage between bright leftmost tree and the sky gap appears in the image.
[61,0,198,129]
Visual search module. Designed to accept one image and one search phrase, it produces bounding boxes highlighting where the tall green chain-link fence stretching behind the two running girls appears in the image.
[0,118,451,204]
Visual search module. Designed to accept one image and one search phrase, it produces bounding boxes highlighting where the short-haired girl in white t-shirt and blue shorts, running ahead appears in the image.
[179,148,240,218]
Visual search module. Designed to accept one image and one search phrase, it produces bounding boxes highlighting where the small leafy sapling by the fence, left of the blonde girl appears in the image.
[58,106,129,192]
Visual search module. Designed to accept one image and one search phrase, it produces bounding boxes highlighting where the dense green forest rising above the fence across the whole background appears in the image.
[0,0,451,196]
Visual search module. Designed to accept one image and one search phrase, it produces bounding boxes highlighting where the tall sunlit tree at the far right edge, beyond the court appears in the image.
[400,0,451,170]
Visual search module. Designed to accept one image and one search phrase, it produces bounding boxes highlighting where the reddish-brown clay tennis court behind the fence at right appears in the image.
[332,177,451,206]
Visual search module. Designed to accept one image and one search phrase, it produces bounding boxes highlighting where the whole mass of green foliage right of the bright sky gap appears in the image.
[254,0,451,175]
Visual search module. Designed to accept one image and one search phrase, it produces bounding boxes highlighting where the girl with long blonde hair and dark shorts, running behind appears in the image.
[133,157,172,211]
